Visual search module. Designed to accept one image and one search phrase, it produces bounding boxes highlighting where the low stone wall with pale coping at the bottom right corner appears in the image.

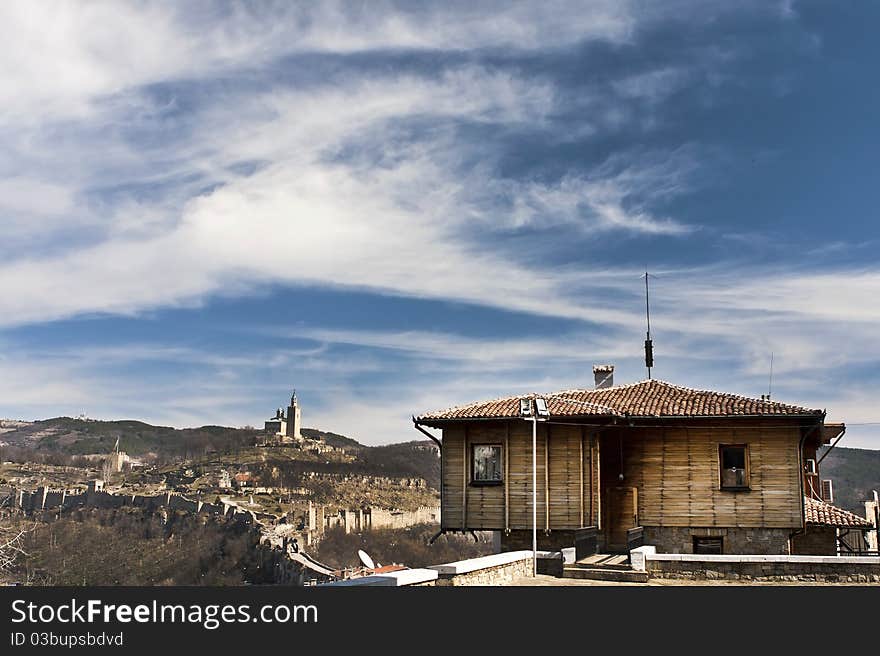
[646,554,880,583]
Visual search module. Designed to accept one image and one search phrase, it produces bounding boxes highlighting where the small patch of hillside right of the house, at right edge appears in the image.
[819,447,880,516]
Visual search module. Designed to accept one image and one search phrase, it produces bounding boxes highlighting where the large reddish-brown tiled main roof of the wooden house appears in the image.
[417,380,823,422]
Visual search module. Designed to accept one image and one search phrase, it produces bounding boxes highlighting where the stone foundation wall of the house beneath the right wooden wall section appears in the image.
[644,526,795,555]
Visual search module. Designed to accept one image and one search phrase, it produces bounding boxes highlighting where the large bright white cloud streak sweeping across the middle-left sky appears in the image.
[0,61,686,325]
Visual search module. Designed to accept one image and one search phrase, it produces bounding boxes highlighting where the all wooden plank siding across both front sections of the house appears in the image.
[442,421,802,530]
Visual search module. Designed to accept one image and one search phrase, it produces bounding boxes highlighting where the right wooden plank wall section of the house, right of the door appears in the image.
[602,427,801,528]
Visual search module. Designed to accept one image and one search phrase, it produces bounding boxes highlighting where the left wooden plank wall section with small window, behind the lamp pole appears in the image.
[441,421,599,530]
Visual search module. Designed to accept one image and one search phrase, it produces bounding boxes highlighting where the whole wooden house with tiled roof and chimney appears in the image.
[414,369,868,554]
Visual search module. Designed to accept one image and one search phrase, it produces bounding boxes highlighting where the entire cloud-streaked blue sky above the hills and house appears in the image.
[0,1,880,448]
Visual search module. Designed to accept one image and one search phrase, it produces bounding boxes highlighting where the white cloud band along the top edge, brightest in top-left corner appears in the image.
[0,0,634,124]
